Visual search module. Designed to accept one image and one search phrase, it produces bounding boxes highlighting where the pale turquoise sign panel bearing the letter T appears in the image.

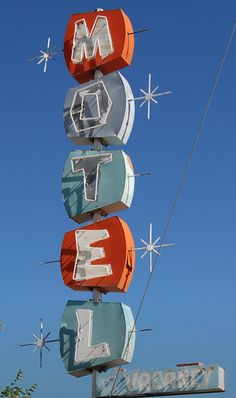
[62,150,135,223]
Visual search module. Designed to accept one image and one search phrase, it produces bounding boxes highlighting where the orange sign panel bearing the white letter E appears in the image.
[61,217,135,293]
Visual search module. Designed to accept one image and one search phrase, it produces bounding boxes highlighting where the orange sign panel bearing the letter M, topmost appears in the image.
[64,10,134,83]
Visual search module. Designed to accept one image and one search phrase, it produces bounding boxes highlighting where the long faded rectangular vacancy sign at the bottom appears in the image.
[97,365,225,398]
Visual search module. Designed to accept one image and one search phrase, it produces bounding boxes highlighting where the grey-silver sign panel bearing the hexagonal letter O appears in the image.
[63,72,135,145]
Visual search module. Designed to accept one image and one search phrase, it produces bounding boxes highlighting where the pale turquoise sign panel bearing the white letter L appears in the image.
[60,301,135,377]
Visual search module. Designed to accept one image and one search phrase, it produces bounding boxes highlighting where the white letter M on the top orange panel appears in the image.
[71,15,114,64]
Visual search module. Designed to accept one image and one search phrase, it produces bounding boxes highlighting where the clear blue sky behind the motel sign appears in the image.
[0,0,236,398]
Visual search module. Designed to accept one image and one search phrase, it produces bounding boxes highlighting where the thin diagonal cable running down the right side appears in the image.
[109,22,236,398]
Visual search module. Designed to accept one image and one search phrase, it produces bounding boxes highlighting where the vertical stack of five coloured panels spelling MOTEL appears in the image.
[60,10,135,377]
